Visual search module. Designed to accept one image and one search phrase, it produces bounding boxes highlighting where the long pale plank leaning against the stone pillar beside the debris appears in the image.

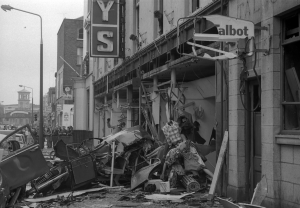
[207,131,228,200]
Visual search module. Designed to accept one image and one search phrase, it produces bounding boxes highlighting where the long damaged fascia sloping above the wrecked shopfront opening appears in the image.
[94,1,220,97]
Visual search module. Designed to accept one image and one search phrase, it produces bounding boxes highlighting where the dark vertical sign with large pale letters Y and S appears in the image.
[90,0,125,58]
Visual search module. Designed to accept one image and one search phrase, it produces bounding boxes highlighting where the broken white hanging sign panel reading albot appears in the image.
[194,15,254,42]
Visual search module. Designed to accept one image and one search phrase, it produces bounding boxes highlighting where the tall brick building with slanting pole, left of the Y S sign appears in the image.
[54,17,83,126]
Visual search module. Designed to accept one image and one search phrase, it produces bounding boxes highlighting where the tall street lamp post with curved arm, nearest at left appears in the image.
[1,5,44,149]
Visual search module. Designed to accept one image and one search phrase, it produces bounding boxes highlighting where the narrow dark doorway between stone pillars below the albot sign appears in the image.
[246,80,262,199]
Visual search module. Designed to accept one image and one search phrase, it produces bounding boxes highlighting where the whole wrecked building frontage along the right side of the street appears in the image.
[73,0,300,207]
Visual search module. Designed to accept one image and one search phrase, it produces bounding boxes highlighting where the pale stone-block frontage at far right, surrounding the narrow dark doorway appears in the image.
[227,0,300,207]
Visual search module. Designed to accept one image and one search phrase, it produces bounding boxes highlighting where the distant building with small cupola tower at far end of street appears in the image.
[0,88,39,126]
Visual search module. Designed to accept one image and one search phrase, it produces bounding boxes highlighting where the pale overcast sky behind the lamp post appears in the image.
[0,0,84,105]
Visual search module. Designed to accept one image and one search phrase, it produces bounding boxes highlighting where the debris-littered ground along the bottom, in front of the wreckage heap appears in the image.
[22,188,223,208]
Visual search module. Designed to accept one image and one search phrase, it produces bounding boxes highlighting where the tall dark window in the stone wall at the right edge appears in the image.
[282,12,300,132]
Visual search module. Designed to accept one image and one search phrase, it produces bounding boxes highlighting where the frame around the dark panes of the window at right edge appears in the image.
[280,10,300,135]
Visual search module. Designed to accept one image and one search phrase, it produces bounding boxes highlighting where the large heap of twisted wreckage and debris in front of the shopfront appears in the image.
[0,126,238,207]
